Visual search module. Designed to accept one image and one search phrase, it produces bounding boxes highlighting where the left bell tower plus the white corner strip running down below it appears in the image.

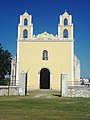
[16,11,33,86]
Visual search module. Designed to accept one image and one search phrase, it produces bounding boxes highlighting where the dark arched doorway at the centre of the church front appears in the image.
[40,68,50,89]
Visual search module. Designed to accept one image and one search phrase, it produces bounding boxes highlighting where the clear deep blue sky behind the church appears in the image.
[0,0,90,78]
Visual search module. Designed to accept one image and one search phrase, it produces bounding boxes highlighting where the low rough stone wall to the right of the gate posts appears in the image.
[68,85,90,97]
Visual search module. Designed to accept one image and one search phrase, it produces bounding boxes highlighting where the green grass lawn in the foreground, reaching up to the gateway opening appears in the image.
[0,91,90,120]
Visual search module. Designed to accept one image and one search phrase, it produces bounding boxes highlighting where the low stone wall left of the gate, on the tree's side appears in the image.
[0,86,19,96]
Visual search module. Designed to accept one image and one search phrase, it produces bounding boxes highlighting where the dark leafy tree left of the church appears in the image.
[0,44,11,83]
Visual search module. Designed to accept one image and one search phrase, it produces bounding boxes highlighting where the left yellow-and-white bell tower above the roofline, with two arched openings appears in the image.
[18,11,33,40]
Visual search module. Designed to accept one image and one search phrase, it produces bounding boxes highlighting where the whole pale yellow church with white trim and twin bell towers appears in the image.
[11,11,80,90]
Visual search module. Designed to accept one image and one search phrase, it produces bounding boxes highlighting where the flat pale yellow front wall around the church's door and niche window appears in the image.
[18,40,73,89]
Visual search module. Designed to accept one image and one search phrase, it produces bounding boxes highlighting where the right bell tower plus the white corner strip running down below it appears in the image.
[58,11,74,85]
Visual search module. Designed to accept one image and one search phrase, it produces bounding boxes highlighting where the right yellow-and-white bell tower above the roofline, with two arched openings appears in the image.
[58,11,73,40]
